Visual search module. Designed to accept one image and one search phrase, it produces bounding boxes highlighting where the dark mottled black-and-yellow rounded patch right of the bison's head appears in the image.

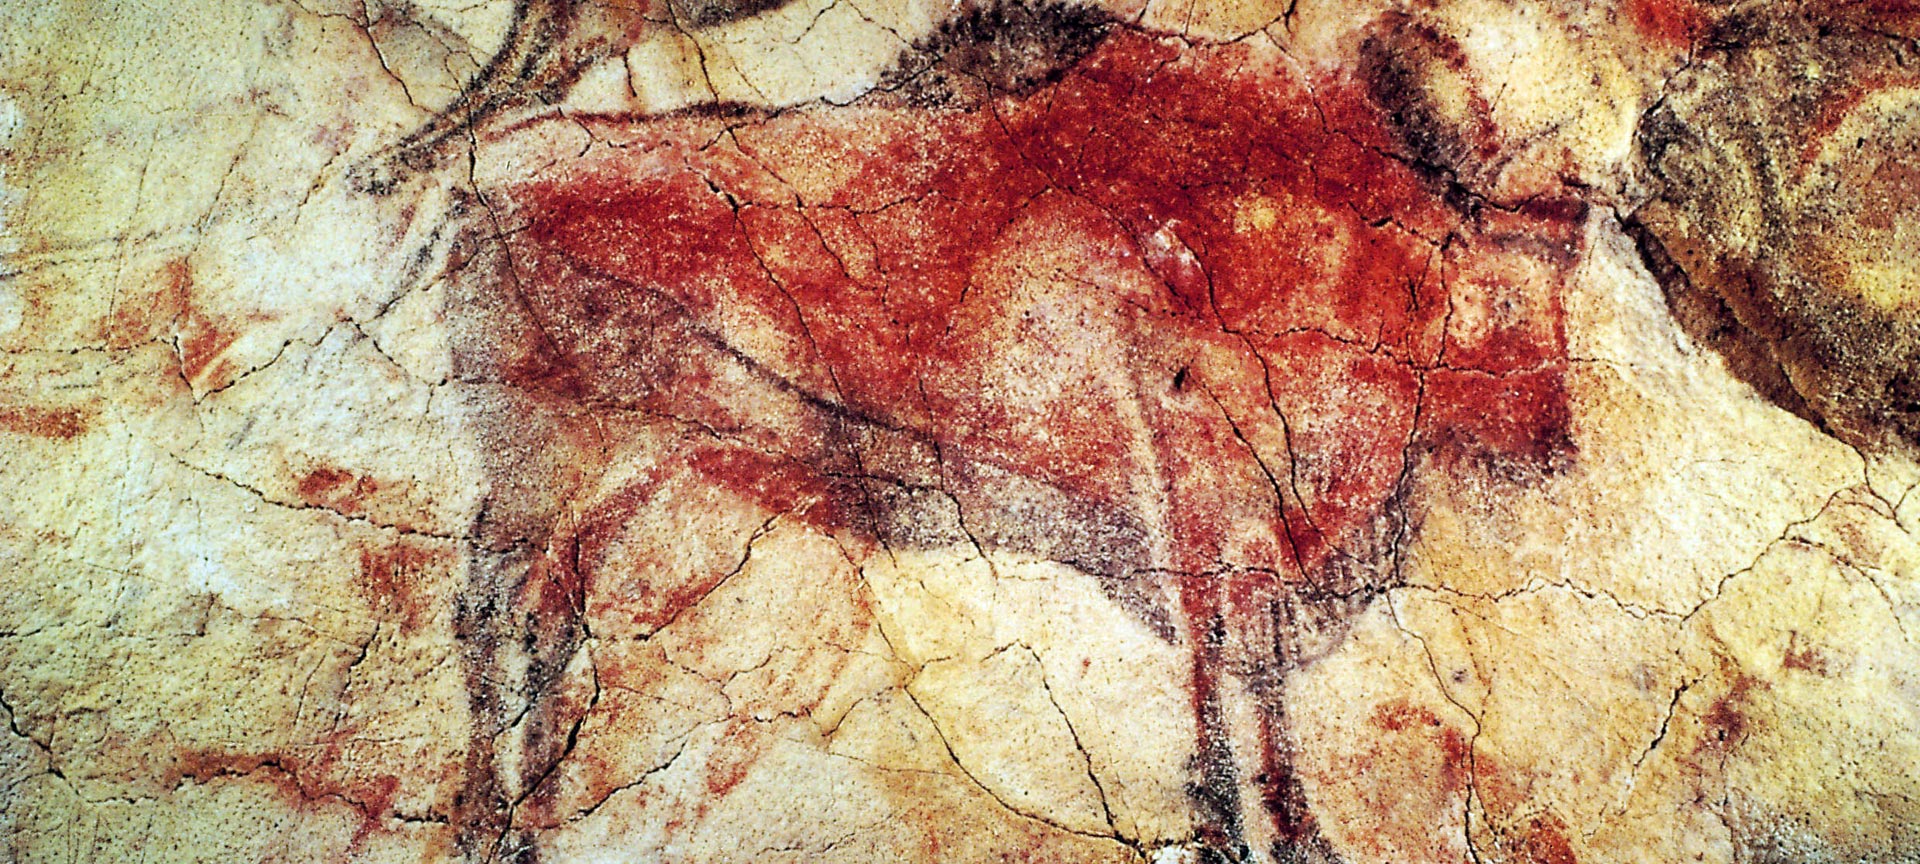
[1626,4,1920,453]
